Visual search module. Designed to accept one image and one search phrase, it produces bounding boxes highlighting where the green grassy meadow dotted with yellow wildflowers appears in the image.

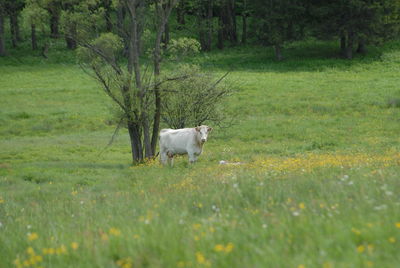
[0,40,400,268]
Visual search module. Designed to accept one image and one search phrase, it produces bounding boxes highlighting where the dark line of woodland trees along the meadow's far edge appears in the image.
[0,0,400,60]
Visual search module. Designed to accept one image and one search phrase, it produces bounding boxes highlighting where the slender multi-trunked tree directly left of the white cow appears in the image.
[78,0,177,163]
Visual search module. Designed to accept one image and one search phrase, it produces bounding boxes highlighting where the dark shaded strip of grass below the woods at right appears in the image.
[190,41,400,72]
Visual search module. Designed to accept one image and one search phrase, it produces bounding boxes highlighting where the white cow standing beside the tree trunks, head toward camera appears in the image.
[160,125,212,166]
